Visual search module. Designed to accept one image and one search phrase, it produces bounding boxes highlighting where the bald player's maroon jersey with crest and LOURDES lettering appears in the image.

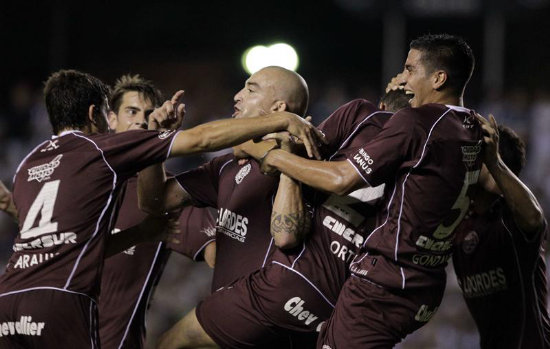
[176,154,278,290]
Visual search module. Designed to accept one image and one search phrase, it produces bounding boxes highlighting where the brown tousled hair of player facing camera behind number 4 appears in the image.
[110,74,162,113]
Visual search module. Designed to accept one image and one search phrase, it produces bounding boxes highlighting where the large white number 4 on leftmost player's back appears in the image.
[21,180,60,239]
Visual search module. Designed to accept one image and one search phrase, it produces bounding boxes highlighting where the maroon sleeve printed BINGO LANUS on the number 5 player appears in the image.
[347,108,421,186]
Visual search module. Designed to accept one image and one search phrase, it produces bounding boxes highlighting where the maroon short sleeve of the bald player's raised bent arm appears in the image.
[176,154,234,208]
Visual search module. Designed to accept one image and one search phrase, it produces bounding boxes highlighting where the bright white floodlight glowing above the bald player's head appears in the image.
[242,43,298,74]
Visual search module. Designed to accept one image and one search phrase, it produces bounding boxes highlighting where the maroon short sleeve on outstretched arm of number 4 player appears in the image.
[94,130,177,177]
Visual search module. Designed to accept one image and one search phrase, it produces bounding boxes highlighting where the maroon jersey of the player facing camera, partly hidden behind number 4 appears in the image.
[98,177,214,349]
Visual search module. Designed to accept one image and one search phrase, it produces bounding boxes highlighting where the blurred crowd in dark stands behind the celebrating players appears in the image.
[0,75,550,349]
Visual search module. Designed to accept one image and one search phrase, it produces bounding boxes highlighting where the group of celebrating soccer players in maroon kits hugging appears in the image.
[0,34,550,349]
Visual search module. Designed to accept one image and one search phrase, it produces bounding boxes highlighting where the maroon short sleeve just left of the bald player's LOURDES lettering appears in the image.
[168,207,216,261]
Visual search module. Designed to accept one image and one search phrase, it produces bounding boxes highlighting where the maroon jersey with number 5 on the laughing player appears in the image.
[348,104,482,292]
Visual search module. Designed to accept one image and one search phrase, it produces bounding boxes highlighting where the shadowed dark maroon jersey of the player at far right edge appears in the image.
[453,204,550,349]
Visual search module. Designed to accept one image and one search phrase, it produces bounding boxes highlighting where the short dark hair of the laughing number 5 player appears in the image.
[410,34,475,93]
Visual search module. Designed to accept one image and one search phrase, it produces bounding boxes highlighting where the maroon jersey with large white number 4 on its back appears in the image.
[0,130,176,298]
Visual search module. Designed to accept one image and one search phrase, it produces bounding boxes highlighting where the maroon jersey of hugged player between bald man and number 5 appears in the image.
[272,99,392,306]
